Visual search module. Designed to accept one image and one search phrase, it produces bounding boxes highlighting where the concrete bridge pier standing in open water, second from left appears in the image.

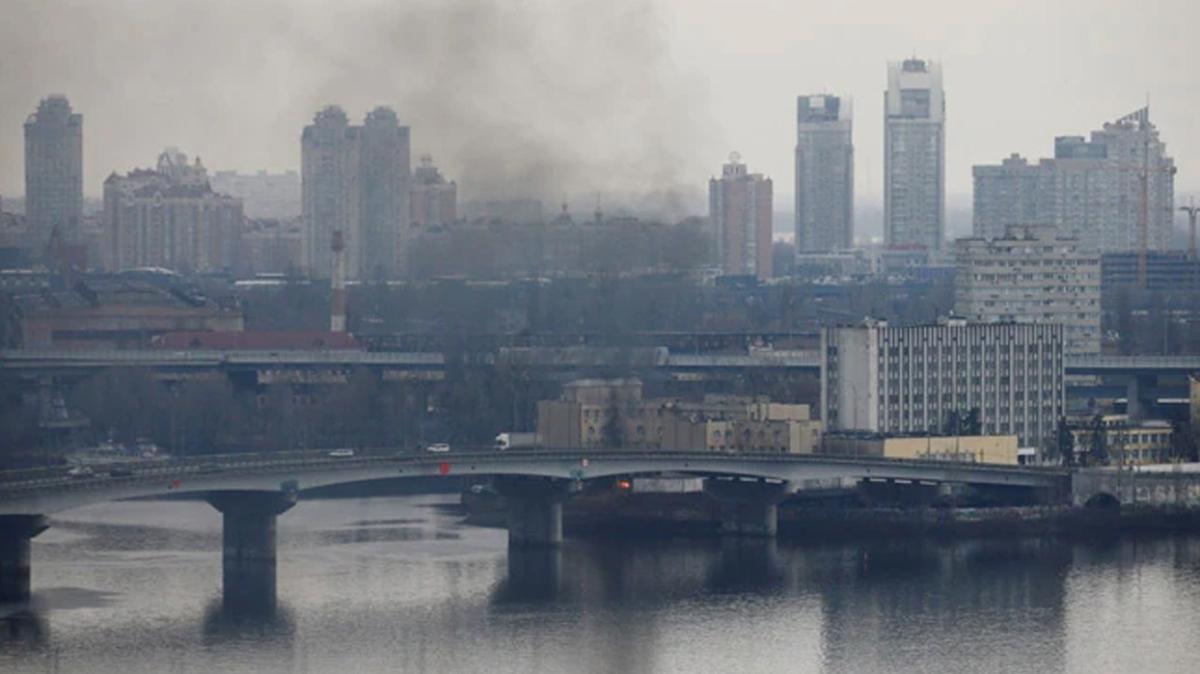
[206,491,296,599]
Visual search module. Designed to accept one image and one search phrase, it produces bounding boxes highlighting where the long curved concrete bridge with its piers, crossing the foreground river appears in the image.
[0,450,1069,603]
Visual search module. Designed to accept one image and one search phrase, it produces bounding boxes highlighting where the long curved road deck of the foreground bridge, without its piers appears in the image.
[0,450,1068,514]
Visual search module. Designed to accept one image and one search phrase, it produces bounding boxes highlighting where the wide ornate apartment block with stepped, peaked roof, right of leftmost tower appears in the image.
[103,148,244,272]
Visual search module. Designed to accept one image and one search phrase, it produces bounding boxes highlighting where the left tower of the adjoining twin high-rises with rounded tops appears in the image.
[300,106,361,278]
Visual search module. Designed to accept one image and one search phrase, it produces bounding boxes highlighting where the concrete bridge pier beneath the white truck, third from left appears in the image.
[496,476,570,548]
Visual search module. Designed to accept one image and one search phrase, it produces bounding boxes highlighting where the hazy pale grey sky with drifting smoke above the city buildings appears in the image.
[0,0,1200,210]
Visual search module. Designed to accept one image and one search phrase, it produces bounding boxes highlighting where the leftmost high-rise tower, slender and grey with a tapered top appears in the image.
[25,96,83,245]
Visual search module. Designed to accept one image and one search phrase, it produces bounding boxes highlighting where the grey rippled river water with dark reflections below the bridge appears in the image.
[7,497,1200,674]
